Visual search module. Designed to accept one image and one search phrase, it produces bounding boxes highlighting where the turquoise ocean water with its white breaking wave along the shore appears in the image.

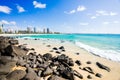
[15,34,120,61]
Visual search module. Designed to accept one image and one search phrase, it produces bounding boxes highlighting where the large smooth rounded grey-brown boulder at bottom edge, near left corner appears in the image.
[6,70,26,80]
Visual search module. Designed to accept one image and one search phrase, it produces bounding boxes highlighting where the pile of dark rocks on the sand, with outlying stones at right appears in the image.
[0,36,110,80]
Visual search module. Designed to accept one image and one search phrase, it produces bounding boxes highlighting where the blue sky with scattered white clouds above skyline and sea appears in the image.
[0,0,120,33]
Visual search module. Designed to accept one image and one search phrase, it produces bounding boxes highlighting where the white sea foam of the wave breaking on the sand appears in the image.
[75,41,120,62]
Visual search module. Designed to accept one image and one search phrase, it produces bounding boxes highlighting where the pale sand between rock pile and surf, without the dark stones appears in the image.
[18,39,120,80]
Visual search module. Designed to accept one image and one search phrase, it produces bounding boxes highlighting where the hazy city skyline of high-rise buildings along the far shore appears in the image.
[0,24,60,34]
